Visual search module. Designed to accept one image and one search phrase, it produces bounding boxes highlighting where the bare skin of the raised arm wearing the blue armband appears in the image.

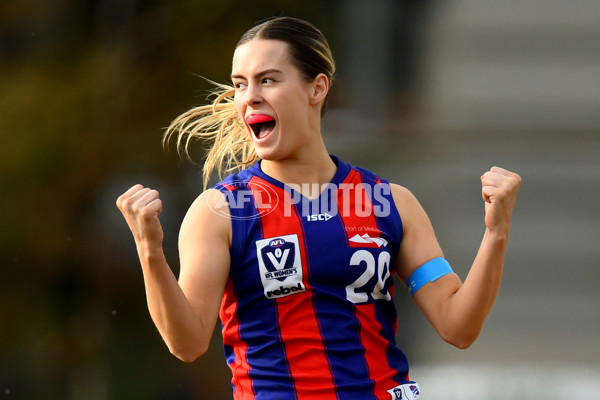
[392,167,521,348]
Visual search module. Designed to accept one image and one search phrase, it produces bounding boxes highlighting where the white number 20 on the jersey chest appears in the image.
[346,250,392,304]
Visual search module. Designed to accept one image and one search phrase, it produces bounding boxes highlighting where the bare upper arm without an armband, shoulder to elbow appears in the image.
[179,190,231,332]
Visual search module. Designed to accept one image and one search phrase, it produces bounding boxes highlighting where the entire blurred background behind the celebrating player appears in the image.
[0,0,600,399]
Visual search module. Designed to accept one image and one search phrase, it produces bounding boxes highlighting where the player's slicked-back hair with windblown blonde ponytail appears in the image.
[163,17,336,188]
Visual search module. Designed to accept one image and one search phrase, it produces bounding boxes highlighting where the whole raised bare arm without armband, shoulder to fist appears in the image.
[117,185,231,362]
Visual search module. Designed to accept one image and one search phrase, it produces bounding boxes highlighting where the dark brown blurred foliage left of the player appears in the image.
[0,0,335,399]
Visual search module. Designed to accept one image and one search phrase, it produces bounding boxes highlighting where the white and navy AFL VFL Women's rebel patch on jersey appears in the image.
[256,235,306,299]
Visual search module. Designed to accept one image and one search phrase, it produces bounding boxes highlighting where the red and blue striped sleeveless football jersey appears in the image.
[216,156,418,400]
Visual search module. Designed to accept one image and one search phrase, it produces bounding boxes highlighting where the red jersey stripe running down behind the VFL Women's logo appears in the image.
[249,177,337,400]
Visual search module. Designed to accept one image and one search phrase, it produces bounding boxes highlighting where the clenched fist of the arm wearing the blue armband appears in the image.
[481,167,521,235]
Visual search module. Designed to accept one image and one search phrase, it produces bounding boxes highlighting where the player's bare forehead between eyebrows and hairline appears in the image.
[231,39,292,75]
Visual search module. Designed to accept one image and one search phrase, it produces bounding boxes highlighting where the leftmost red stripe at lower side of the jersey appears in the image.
[219,279,256,400]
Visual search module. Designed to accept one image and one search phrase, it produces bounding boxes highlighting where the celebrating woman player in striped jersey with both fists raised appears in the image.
[117,17,521,400]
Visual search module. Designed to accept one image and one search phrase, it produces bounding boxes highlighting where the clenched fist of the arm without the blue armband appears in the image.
[117,185,163,250]
